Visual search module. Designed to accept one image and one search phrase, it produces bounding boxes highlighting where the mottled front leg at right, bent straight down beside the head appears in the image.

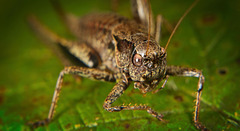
[166,66,205,129]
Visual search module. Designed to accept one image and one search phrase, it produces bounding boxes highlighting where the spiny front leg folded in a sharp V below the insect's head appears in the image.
[103,80,163,121]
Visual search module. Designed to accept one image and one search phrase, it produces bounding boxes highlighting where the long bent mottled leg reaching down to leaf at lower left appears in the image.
[32,66,116,127]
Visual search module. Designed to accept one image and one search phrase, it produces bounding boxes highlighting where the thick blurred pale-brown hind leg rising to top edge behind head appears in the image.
[131,0,155,35]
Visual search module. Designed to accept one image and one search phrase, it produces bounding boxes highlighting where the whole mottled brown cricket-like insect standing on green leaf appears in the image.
[29,0,205,129]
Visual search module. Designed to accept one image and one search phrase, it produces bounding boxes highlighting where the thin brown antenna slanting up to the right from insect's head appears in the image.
[165,0,199,52]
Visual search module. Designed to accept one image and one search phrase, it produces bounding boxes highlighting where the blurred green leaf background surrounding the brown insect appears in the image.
[0,0,240,130]
